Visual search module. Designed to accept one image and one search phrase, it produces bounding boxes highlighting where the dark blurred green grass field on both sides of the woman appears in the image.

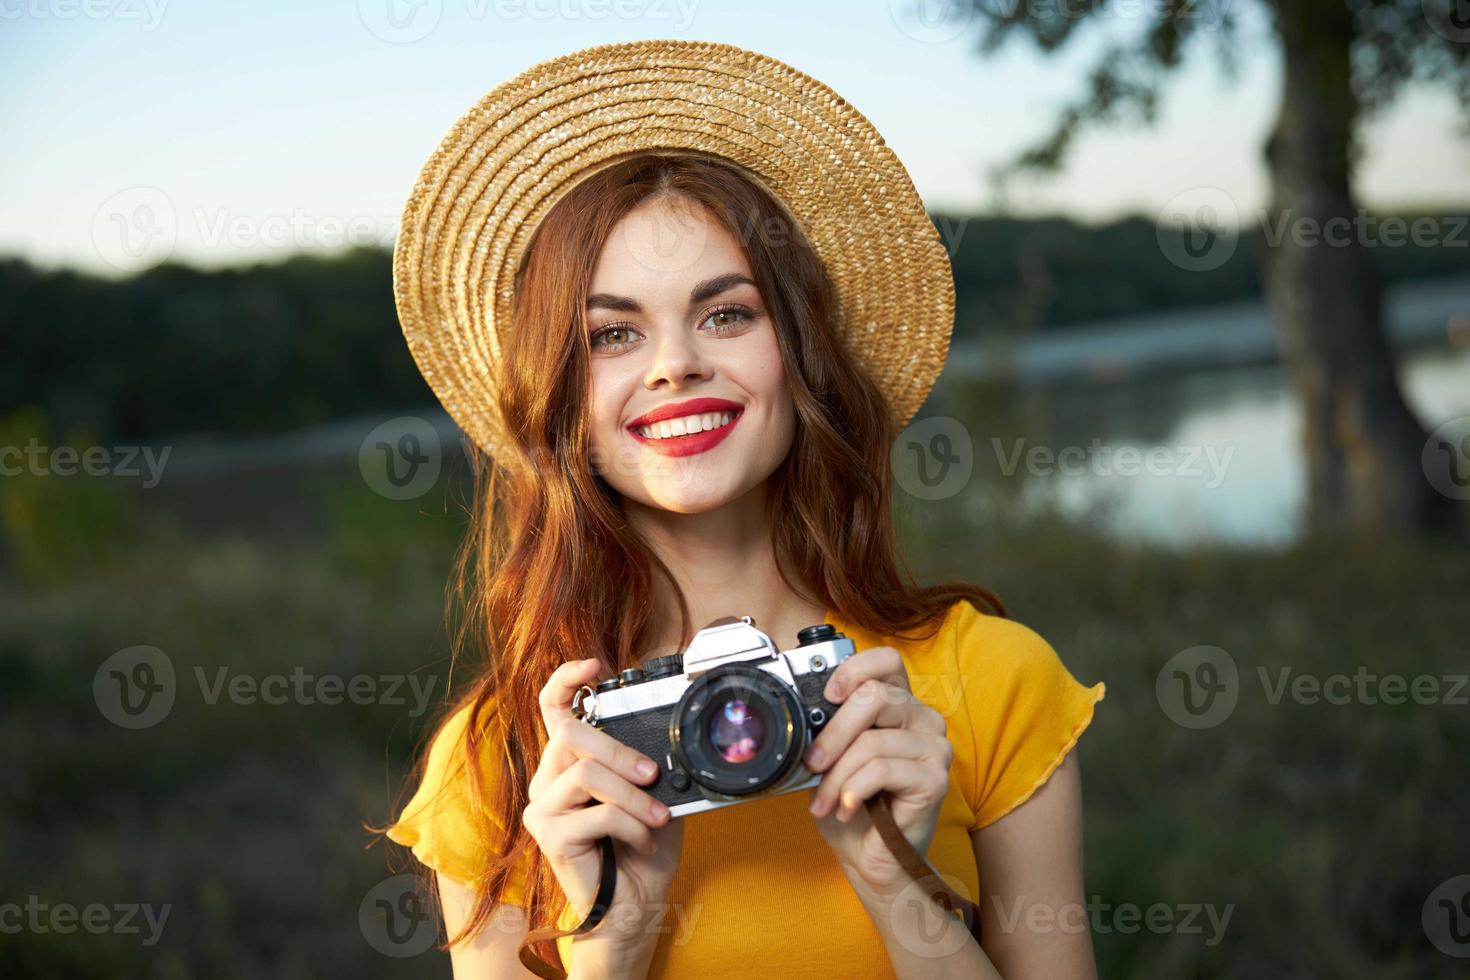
[0,455,1470,980]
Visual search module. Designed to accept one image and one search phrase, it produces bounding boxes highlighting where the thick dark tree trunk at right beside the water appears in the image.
[1263,0,1457,535]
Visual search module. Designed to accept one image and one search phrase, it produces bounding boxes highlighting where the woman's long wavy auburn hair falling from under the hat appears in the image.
[385,151,1005,962]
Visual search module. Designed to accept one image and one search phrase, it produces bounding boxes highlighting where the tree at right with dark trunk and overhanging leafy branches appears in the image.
[951,0,1470,535]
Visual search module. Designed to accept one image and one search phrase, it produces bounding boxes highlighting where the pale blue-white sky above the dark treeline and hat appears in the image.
[0,0,1470,275]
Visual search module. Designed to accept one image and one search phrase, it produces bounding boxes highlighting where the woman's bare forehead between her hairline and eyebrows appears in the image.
[589,197,750,294]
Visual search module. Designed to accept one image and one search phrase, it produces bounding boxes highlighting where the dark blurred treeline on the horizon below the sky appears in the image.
[0,213,1470,439]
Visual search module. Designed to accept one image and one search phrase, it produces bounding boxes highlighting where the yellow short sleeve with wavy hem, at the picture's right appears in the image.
[954,601,1107,829]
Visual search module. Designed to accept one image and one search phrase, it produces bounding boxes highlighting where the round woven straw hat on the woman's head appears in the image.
[392,40,954,455]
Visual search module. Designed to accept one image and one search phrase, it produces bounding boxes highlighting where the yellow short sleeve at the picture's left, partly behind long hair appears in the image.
[388,705,526,908]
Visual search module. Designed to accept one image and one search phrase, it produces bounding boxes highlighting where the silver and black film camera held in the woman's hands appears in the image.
[572,616,856,817]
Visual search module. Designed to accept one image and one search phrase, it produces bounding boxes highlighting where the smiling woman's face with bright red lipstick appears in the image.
[587,197,795,513]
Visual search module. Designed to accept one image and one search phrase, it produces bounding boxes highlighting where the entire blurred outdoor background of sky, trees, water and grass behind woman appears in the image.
[0,0,1470,980]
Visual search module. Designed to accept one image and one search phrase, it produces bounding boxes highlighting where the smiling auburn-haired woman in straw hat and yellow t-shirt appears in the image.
[388,41,1104,980]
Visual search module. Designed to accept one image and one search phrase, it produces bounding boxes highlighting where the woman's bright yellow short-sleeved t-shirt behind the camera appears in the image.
[388,601,1105,980]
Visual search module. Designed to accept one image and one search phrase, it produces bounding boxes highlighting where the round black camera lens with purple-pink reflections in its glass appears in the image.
[669,664,806,796]
